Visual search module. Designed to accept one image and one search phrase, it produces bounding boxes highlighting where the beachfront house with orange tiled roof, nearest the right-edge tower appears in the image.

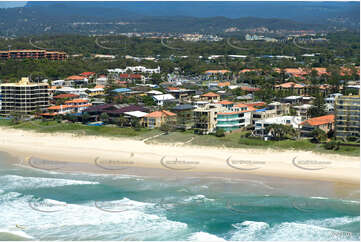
[300,114,335,138]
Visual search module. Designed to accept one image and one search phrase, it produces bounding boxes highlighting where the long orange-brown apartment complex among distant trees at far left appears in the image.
[0,50,68,60]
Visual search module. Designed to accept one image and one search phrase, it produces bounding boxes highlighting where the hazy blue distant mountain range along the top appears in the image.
[0,2,360,36]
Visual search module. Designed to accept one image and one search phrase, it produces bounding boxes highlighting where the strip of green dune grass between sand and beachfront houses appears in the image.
[0,119,360,156]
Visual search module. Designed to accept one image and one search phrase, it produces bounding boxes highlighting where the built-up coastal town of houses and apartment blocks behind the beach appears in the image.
[0,50,360,150]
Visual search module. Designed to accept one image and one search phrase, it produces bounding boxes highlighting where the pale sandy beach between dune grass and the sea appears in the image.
[0,128,360,185]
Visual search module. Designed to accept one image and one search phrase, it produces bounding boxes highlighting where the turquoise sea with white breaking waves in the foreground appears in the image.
[0,154,360,241]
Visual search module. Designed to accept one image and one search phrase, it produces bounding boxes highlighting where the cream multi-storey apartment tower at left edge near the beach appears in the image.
[0,77,50,115]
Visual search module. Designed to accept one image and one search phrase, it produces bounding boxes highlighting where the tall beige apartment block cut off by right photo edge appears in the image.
[335,95,360,139]
